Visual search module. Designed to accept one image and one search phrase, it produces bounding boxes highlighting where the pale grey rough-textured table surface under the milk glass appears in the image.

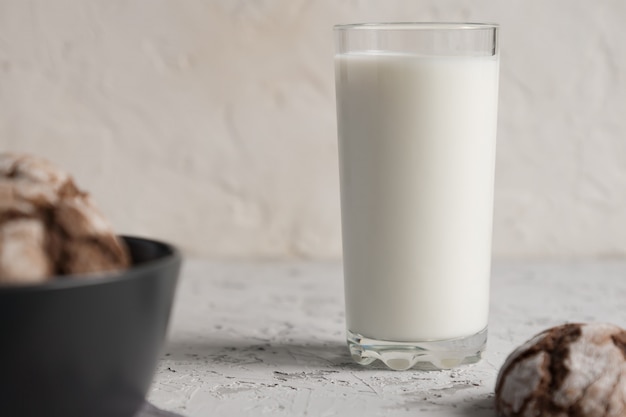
[148,260,626,417]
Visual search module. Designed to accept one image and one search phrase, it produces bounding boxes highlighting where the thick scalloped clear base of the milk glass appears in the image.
[348,327,487,371]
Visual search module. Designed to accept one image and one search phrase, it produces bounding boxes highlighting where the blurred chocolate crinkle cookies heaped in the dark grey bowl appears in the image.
[0,153,130,284]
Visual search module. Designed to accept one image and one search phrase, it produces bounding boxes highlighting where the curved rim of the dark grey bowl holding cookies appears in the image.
[0,235,182,295]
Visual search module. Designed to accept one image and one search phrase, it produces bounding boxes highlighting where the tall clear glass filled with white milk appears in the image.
[334,23,499,370]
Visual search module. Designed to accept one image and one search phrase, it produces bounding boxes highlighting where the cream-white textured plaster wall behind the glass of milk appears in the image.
[0,0,626,257]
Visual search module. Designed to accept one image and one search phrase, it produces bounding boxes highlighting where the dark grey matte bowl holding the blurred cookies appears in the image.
[0,237,182,417]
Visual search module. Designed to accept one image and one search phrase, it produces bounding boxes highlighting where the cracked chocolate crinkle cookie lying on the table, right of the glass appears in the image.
[496,323,626,417]
